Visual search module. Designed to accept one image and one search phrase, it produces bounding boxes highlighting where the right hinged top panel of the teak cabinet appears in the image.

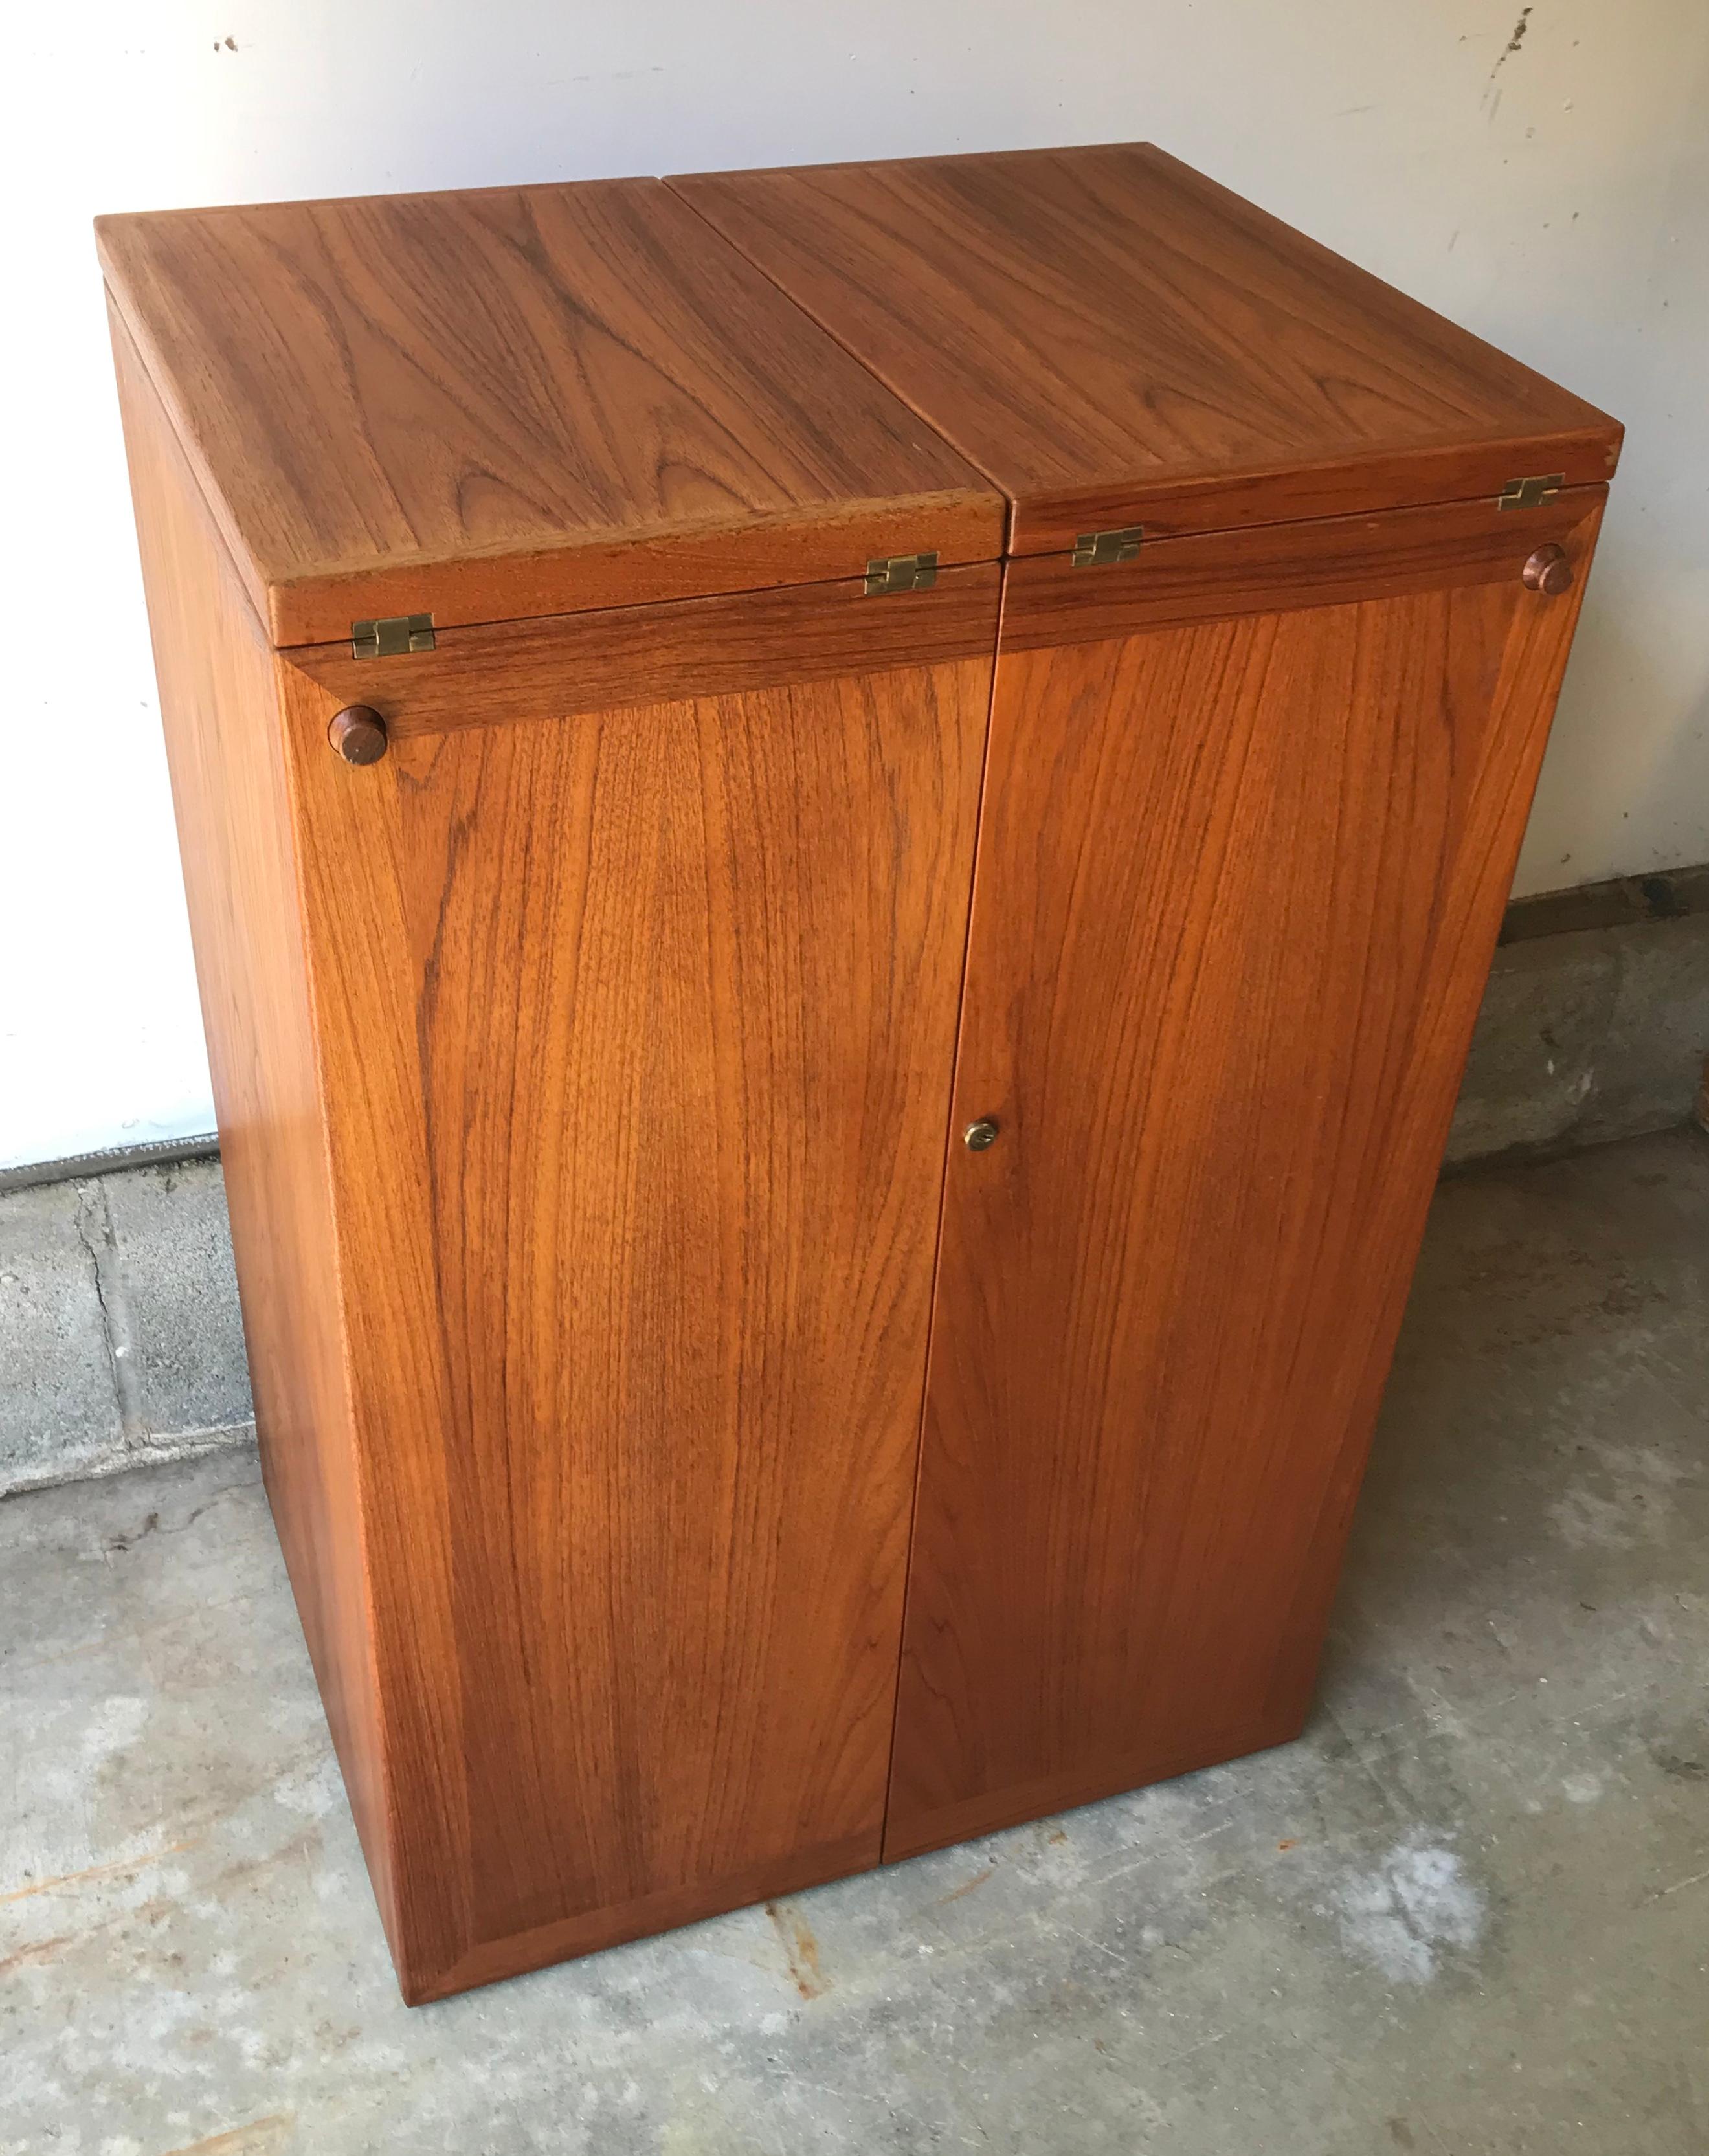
[670,144,1621,554]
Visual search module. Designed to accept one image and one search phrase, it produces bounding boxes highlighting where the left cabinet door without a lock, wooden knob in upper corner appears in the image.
[282,569,996,1997]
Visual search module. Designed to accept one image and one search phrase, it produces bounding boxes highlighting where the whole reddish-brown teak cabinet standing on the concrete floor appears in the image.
[99,147,1618,2001]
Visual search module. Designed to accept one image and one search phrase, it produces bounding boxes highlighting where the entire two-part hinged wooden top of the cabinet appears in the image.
[97,144,1621,645]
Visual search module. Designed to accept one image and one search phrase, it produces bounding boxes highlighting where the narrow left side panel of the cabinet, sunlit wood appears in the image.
[112,317,392,1949]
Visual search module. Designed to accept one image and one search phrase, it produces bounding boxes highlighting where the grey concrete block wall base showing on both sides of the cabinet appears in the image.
[0,869,1709,1494]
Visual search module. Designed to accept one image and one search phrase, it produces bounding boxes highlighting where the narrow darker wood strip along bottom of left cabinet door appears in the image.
[399,1826,879,2007]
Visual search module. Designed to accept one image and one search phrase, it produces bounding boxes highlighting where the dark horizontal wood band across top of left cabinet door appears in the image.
[287,562,1002,740]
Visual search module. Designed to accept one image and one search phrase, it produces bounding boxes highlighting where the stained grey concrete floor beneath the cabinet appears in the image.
[0,1132,1709,2156]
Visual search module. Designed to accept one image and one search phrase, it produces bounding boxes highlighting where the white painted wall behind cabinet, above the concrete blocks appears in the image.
[0,0,1709,1164]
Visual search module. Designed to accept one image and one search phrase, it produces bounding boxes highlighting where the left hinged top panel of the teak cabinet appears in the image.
[97,179,1004,645]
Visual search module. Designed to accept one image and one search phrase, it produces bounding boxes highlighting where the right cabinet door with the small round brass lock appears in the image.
[886,487,1603,1856]
